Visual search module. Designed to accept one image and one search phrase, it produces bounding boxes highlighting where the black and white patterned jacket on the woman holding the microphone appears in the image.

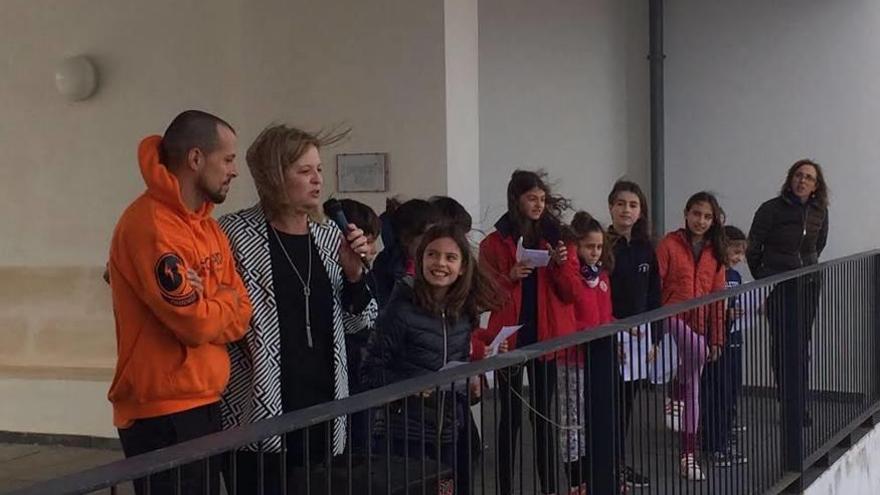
[219,204,377,455]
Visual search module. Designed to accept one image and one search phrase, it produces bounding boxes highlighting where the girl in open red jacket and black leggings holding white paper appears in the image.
[479,170,581,495]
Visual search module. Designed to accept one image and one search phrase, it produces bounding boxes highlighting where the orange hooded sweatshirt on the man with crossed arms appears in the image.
[108,136,251,428]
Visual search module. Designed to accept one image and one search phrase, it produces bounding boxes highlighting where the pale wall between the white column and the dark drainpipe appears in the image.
[479,0,649,228]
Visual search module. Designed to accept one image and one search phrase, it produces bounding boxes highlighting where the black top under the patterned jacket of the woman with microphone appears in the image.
[269,229,333,412]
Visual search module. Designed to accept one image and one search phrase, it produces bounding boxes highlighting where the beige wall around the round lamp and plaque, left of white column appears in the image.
[0,0,446,266]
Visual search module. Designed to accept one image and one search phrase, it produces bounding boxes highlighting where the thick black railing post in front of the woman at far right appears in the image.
[777,276,807,493]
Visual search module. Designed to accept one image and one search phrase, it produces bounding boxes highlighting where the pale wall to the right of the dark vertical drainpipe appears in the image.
[666,0,880,259]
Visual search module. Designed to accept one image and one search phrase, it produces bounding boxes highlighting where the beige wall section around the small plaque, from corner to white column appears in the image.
[236,0,446,218]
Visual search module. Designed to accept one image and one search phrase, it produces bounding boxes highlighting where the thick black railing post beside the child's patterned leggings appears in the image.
[584,335,621,493]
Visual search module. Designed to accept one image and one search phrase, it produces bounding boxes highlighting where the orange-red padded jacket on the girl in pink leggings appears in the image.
[657,229,726,345]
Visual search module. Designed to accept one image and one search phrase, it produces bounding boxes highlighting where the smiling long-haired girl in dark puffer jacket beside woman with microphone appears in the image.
[367,225,498,494]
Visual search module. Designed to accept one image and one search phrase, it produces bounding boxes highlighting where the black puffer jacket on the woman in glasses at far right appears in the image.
[746,193,828,279]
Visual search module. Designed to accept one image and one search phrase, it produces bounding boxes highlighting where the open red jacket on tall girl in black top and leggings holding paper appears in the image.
[477,216,581,360]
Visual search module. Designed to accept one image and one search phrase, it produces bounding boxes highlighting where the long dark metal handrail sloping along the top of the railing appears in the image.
[9,249,880,495]
